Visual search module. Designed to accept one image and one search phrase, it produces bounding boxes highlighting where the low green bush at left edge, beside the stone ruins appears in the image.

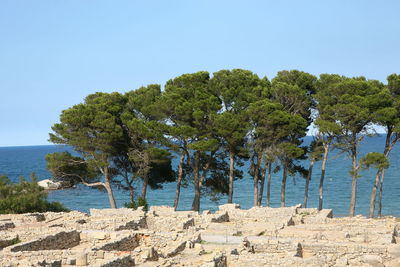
[0,173,68,214]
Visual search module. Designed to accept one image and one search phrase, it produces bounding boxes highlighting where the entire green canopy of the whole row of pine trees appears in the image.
[43,69,400,215]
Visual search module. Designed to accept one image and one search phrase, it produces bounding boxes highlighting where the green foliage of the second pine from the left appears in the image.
[122,84,175,192]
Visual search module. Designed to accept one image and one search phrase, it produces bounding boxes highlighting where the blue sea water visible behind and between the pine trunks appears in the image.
[0,135,400,216]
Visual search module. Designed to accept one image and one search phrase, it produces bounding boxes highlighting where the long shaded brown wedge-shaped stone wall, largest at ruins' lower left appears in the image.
[9,231,81,252]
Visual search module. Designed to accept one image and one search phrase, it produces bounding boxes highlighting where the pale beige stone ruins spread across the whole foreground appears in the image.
[0,204,400,267]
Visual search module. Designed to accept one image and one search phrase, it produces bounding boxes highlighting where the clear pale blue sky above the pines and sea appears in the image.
[0,0,400,146]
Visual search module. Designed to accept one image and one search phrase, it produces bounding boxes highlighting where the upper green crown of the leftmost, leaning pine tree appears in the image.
[50,93,126,157]
